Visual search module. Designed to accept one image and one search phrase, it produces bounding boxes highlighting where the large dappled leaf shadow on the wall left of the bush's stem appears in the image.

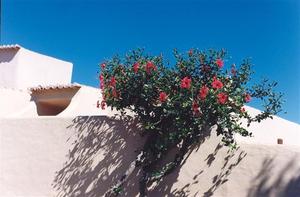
[53,116,142,197]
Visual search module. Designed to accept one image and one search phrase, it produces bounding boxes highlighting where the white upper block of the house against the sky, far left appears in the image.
[0,45,73,89]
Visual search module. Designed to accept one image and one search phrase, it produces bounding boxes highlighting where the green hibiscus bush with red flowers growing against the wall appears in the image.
[98,49,282,196]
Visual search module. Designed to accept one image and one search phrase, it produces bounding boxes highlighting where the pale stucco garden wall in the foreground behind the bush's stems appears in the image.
[0,116,300,197]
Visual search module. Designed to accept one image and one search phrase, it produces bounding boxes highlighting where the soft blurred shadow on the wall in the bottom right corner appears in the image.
[247,158,300,197]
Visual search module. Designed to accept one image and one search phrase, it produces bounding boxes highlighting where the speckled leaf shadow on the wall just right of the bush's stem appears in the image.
[150,143,247,197]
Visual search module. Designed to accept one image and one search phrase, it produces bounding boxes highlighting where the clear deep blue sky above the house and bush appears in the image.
[1,0,300,123]
